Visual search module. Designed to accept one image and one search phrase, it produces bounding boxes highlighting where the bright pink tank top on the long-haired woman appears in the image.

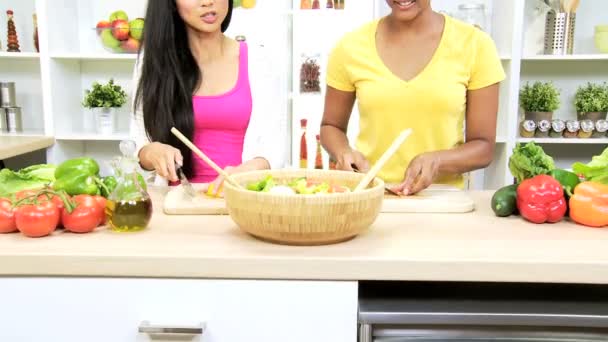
[191,42,252,183]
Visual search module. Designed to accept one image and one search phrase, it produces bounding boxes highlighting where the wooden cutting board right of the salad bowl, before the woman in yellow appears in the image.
[381,184,475,213]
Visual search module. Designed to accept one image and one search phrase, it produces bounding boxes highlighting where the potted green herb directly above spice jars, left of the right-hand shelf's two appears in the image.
[519,81,560,122]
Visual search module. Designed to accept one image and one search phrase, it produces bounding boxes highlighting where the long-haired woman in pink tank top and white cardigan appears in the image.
[132,0,280,196]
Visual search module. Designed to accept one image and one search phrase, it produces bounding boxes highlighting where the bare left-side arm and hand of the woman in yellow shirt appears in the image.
[321,86,369,171]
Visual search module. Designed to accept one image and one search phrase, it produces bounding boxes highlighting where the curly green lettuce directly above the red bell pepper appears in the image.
[509,142,555,183]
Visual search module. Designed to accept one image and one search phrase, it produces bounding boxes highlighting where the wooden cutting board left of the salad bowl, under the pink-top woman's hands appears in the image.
[163,184,228,215]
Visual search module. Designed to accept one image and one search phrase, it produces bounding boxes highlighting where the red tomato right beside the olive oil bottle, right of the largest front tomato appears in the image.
[61,195,104,233]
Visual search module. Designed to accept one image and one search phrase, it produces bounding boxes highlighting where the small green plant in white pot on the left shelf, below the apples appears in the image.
[82,79,127,134]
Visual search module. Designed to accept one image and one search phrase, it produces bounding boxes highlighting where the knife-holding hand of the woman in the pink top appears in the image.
[139,142,184,182]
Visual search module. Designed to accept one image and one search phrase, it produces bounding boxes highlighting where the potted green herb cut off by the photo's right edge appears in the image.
[574,83,608,122]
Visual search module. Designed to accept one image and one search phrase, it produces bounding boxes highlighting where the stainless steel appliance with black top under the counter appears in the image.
[359,283,608,342]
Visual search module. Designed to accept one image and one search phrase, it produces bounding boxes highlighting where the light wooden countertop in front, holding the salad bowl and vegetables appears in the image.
[0,192,608,283]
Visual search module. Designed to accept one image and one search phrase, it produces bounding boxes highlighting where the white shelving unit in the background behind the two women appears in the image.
[0,0,608,189]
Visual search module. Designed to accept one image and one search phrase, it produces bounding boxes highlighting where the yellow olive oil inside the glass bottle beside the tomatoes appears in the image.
[106,198,152,232]
